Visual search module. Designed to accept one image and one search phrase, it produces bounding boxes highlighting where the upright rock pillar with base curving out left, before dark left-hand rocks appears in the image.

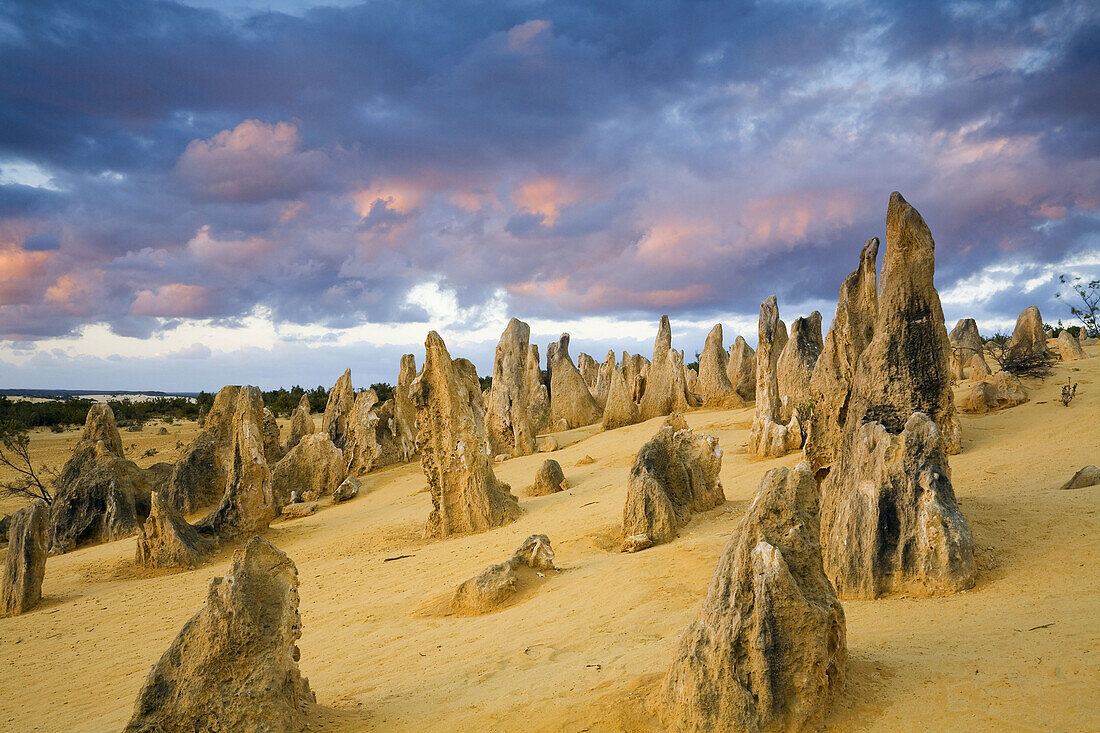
[196,386,275,539]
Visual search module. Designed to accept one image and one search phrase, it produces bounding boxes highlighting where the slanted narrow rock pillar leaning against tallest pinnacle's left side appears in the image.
[805,237,879,471]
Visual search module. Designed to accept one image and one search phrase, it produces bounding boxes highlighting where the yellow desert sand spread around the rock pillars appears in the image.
[0,348,1100,731]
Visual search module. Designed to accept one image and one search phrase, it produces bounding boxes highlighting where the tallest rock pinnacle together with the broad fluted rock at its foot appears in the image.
[821,192,975,598]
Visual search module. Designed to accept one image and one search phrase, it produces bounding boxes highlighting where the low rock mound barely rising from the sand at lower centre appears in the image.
[413,535,558,616]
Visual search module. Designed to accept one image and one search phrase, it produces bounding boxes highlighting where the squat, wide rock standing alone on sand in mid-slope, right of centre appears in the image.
[622,416,726,551]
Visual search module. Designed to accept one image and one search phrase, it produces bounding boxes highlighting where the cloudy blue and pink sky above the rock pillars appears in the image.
[0,0,1100,391]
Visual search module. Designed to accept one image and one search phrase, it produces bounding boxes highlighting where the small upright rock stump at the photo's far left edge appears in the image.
[0,499,48,616]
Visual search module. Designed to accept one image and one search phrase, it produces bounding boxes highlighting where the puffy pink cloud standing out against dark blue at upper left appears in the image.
[176,120,329,201]
